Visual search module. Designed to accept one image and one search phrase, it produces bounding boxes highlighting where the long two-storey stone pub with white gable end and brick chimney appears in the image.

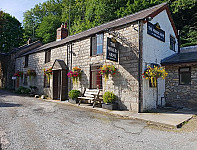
[13,3,178,112]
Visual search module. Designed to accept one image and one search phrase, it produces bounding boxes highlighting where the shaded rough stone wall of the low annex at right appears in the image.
[165,64,197,109]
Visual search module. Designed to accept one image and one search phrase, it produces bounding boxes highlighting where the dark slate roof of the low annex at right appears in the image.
[161,52,197,65]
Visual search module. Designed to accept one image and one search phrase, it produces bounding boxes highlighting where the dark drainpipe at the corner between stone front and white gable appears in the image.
[138,20,143,113]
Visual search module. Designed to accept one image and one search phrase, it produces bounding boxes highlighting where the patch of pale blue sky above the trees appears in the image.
[0,0,47,23]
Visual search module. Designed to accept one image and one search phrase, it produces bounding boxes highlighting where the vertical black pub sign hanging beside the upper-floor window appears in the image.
[106,38,118,62]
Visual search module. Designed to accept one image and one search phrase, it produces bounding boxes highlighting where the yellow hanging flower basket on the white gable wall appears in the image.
[142,66,168,87]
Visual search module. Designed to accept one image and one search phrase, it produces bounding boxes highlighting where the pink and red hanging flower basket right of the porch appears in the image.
[67,67,81,83]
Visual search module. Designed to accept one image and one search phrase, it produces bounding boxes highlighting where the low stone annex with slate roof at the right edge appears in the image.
[162,46,197,109]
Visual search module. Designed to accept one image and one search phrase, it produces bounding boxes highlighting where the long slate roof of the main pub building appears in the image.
[21,3,168,56]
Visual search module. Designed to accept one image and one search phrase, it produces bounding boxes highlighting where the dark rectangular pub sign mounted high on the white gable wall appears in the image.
[147,22,165,42]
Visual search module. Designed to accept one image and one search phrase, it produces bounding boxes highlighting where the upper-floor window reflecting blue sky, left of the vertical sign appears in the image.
[90,34,103,56]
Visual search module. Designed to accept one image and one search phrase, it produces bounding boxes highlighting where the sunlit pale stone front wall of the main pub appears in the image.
[16,23,139,111]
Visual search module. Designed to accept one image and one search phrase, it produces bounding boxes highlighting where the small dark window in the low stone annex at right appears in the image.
[179,67,191,85]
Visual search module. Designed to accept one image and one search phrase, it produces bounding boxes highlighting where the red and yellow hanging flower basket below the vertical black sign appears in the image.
[99,65,118,81]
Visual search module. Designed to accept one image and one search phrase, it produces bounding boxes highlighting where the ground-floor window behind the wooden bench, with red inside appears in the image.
[90,66,103,89]
